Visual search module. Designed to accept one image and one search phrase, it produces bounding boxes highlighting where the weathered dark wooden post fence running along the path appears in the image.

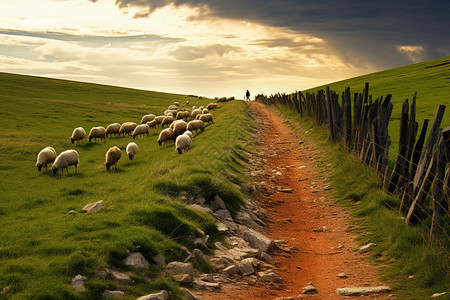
[256,83,450,245]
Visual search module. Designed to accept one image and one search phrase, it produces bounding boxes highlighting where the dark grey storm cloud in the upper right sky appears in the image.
[111,0,450,68]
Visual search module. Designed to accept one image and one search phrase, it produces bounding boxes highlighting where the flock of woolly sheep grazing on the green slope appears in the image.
[36,101,217,174]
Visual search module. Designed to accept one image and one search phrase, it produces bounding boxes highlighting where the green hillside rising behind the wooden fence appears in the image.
[305,57,450,155]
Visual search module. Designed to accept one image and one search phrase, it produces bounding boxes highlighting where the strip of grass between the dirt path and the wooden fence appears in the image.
[277,98,450,299]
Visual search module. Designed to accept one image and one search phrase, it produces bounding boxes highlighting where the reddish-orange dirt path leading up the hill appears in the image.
[201,102,390,299]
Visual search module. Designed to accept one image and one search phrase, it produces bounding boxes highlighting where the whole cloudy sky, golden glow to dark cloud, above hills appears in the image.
[0,0,450,99]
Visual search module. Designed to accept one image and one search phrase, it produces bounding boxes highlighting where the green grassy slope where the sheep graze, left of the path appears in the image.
[0,73,251,299]
